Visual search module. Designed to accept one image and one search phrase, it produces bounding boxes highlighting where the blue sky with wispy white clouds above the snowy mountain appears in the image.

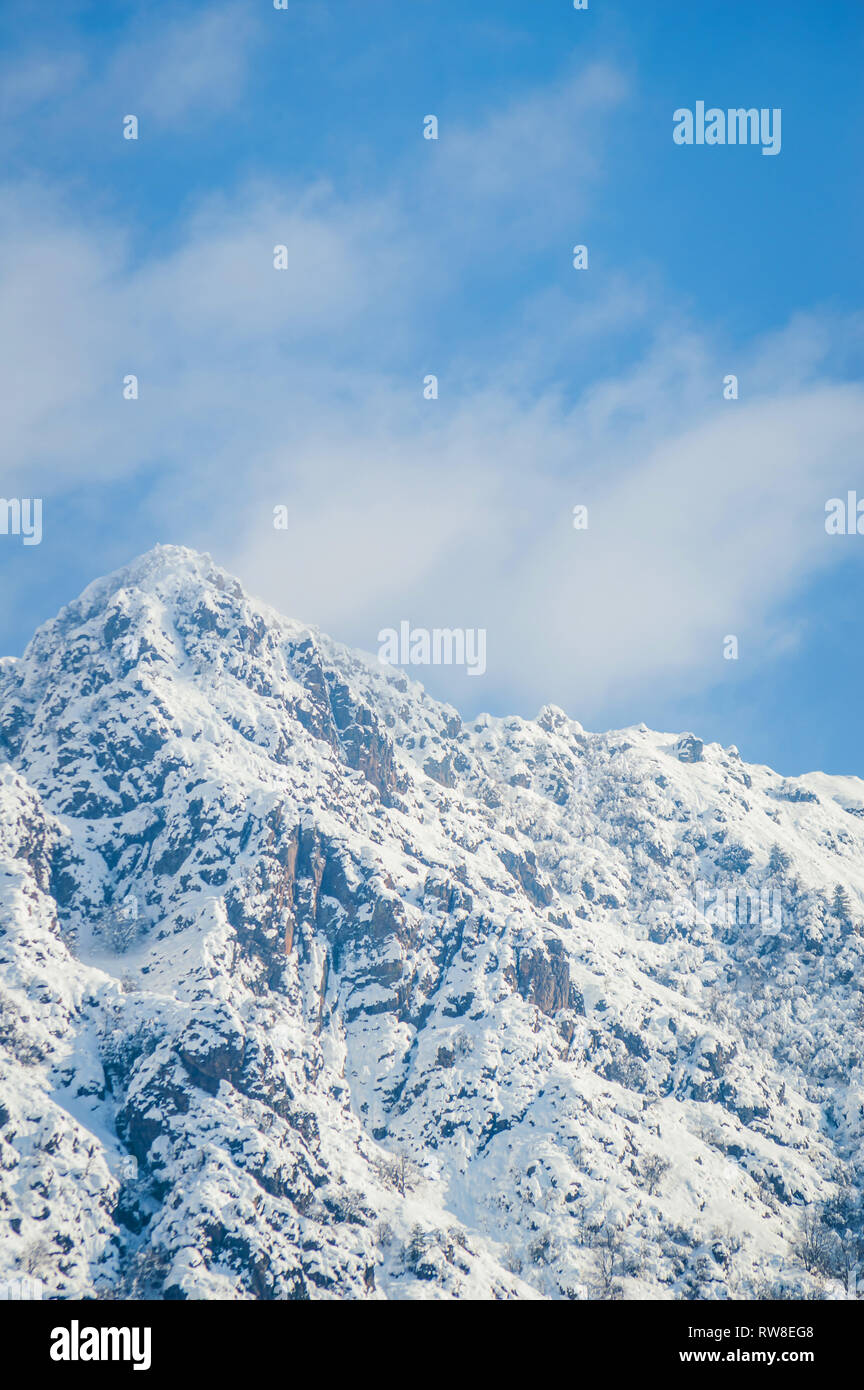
[0,0,864,774]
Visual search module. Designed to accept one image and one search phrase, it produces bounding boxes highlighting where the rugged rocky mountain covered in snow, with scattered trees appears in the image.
[0,548,864,1298]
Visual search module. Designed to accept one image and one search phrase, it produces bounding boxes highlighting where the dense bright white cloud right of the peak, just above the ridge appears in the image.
[228,349,864,721]
